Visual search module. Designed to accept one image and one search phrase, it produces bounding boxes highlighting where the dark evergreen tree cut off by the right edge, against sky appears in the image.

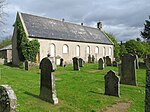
[141,17,150,40]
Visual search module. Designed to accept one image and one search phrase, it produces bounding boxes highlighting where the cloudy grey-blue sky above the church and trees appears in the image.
[0,0,150,41]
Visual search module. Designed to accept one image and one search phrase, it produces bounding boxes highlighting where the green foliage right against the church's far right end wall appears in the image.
[105,33,120,57]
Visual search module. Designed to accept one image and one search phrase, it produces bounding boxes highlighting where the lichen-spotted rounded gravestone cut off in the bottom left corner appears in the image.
[0,85,17,112]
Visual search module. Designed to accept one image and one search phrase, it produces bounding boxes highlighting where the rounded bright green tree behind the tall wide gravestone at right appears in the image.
[125,40,144,57]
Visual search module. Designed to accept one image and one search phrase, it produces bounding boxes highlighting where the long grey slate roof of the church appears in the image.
[21,13,113,44]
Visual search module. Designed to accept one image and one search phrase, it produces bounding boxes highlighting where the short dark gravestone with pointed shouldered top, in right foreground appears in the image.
[104,70,120,97]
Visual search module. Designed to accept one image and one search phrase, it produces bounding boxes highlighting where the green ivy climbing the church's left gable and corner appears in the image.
[16,19,40,61]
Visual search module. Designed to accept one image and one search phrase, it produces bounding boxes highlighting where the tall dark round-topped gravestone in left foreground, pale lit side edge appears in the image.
[40,57,58,104]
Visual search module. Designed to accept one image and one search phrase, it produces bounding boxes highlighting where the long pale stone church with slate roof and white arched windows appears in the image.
[12,12,114,65]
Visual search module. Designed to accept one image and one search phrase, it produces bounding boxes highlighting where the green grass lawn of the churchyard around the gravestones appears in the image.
[0,64,146,112]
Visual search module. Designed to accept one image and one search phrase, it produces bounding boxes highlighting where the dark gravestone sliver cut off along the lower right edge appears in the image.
[145,55,150,112]
